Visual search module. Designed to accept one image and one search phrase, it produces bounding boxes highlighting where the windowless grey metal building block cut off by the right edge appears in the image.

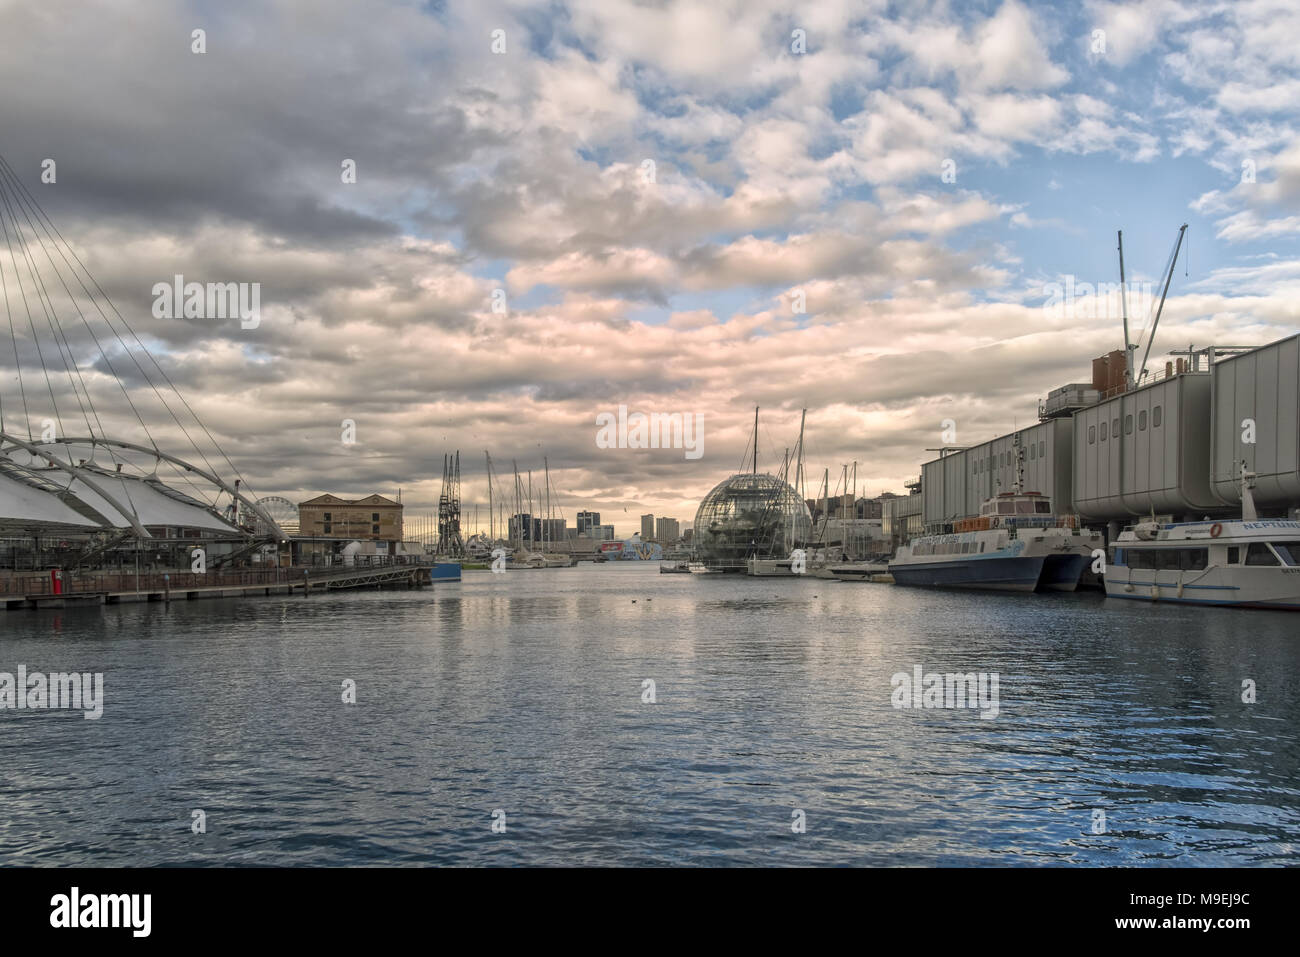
[1210,335,1300,507]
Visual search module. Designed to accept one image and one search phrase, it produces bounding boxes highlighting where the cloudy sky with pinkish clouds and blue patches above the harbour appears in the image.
[0,0,1300,534]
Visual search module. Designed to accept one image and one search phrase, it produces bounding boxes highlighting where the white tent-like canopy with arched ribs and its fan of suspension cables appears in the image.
[0,148,285,544]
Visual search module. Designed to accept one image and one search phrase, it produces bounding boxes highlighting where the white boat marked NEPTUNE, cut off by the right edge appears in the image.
[1105,467,1300,611]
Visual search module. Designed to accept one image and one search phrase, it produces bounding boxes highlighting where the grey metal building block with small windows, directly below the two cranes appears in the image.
[1074,373,1223,521]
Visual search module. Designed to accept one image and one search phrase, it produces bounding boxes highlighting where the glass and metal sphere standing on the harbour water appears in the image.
[694,472,813,567]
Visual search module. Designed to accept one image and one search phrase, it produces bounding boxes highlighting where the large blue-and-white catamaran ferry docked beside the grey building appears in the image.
[889,492,1104,592]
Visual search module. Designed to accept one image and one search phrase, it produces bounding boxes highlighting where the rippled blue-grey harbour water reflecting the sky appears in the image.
[0,563,1300,865]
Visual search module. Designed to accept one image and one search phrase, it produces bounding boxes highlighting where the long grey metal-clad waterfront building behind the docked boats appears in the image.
[915,335,1300,540]
